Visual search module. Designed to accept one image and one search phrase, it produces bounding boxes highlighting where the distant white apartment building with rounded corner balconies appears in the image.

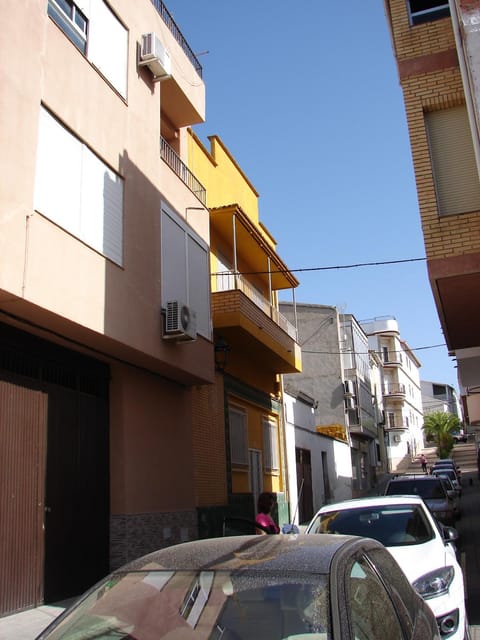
[360,317,424,471]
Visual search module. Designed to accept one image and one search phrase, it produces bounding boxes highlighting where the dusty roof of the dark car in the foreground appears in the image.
[119,534,378,574]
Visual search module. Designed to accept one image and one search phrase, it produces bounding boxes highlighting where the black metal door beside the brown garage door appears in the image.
[45,388,109,602]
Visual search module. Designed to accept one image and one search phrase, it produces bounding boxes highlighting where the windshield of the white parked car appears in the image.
[309,504,434,547]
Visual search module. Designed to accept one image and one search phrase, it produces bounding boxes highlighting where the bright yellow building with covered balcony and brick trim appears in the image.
[188,131,301,536]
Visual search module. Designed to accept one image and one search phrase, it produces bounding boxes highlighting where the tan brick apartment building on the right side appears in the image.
[385,0,480,424]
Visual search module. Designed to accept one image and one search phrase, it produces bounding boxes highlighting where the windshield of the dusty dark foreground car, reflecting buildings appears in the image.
[39,570,331,640]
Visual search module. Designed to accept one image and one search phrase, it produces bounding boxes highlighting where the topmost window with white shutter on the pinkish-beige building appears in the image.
[47,0,128,97]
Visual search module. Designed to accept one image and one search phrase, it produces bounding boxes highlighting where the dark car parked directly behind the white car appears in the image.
[385,474,456,526]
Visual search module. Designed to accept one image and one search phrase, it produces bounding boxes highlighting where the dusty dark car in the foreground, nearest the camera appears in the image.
[33,535,441,640]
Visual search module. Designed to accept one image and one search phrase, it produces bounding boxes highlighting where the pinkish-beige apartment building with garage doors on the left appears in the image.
[0,0,215,614]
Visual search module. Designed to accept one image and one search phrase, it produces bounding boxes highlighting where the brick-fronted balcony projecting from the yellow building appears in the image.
[212,274,301,373]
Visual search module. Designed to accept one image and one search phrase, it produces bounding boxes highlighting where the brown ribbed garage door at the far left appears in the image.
[0,380,47,615]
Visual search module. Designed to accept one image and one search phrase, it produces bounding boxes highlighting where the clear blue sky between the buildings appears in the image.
[166,0,458,388]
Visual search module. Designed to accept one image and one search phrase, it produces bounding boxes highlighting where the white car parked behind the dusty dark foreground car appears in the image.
[306,495,469,640]
